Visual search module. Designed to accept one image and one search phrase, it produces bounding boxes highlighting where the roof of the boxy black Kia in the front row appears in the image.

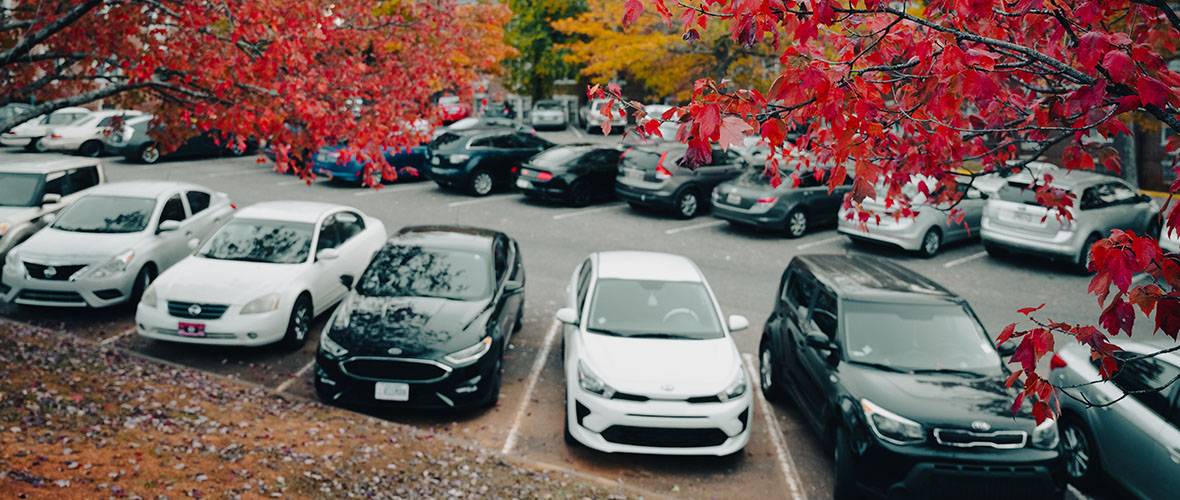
[792,254,958,302]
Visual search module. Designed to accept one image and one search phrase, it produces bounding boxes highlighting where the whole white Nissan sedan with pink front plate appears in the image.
[136,202,386,349]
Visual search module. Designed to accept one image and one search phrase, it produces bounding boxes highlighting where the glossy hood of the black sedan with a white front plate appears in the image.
[330,294,489,360]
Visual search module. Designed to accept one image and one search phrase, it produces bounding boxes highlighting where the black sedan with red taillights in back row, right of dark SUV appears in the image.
[516,144,621,206]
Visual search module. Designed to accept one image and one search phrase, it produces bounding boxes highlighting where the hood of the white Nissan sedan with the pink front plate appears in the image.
[155,256,304,305]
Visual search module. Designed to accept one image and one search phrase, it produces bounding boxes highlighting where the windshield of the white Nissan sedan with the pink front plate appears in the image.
[198,219,315,264]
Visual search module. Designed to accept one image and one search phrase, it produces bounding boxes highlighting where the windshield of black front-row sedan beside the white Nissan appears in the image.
[356,245,492,301]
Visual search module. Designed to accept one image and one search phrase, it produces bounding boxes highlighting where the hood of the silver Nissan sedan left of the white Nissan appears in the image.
[19,228,151,264]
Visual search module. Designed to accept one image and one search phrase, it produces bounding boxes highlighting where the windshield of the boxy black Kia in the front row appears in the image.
[843,301,1001,374]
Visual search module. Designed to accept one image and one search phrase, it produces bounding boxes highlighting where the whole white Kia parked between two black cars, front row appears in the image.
[557,251,753,455]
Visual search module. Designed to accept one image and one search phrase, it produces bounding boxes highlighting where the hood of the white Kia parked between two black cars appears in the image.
[582,334,741,397]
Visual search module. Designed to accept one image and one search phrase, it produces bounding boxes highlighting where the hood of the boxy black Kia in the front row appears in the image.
[837,363,1034,432]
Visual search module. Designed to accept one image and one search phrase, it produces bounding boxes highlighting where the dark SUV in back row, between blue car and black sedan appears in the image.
[425,129,553,196]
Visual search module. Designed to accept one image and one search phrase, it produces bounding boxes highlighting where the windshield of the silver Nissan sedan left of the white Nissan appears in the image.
[53,196,156,232]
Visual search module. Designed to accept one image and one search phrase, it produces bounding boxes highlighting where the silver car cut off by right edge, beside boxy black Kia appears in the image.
[1050,336,1180,499]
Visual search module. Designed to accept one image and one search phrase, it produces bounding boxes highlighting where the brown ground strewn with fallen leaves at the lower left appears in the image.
[0,320,628,500]
